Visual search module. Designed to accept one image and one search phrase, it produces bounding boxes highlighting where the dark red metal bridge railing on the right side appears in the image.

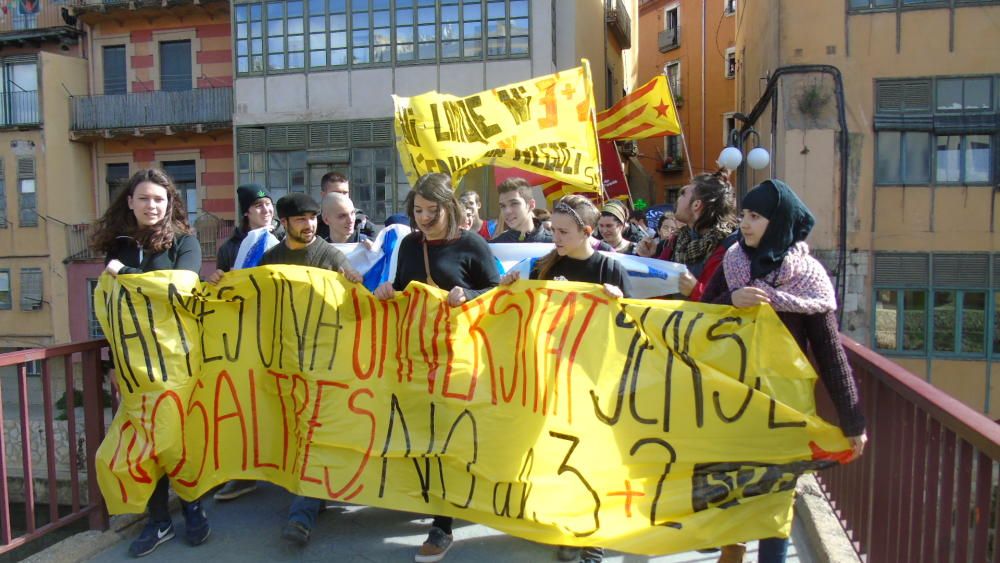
[818,337,1000,563]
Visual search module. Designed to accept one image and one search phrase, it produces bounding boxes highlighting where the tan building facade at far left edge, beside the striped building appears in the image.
[0,3,92,351]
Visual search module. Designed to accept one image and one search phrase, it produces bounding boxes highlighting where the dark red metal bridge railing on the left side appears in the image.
[0,340,116,560]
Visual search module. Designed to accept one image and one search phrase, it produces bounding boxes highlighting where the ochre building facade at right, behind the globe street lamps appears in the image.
[736,0,1000,418]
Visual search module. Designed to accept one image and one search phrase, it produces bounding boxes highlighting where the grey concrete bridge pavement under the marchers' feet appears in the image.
[80,483,813,563]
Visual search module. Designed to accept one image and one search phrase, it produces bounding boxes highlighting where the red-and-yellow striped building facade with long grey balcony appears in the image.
[66,0,235,340]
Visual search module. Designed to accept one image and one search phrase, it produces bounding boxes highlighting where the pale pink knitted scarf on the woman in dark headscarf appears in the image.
[722,241,837,314]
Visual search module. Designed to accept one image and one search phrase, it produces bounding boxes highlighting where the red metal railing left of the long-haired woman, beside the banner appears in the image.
[0,340,108,554]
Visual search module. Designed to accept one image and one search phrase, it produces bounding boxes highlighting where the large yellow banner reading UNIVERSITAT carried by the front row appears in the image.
[95,266,849,554]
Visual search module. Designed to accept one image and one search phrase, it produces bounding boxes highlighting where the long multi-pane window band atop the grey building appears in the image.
[233,0,530,74]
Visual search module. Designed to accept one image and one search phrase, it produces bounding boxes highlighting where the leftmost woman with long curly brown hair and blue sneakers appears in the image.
[92,168,212,557]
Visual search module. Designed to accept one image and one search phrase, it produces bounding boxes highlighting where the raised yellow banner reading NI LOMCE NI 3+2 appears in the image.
[392,59,601,192]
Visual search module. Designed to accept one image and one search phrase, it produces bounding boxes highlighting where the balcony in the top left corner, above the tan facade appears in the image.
[0,1,81,50]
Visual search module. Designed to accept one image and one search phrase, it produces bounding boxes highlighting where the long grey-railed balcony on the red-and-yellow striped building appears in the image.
[70,88,233,140]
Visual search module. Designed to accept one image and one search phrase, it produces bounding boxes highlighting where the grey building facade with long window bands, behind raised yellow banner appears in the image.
[233,0,637,222]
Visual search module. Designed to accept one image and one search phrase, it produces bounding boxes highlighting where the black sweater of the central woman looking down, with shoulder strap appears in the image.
[392,231,500,300]
